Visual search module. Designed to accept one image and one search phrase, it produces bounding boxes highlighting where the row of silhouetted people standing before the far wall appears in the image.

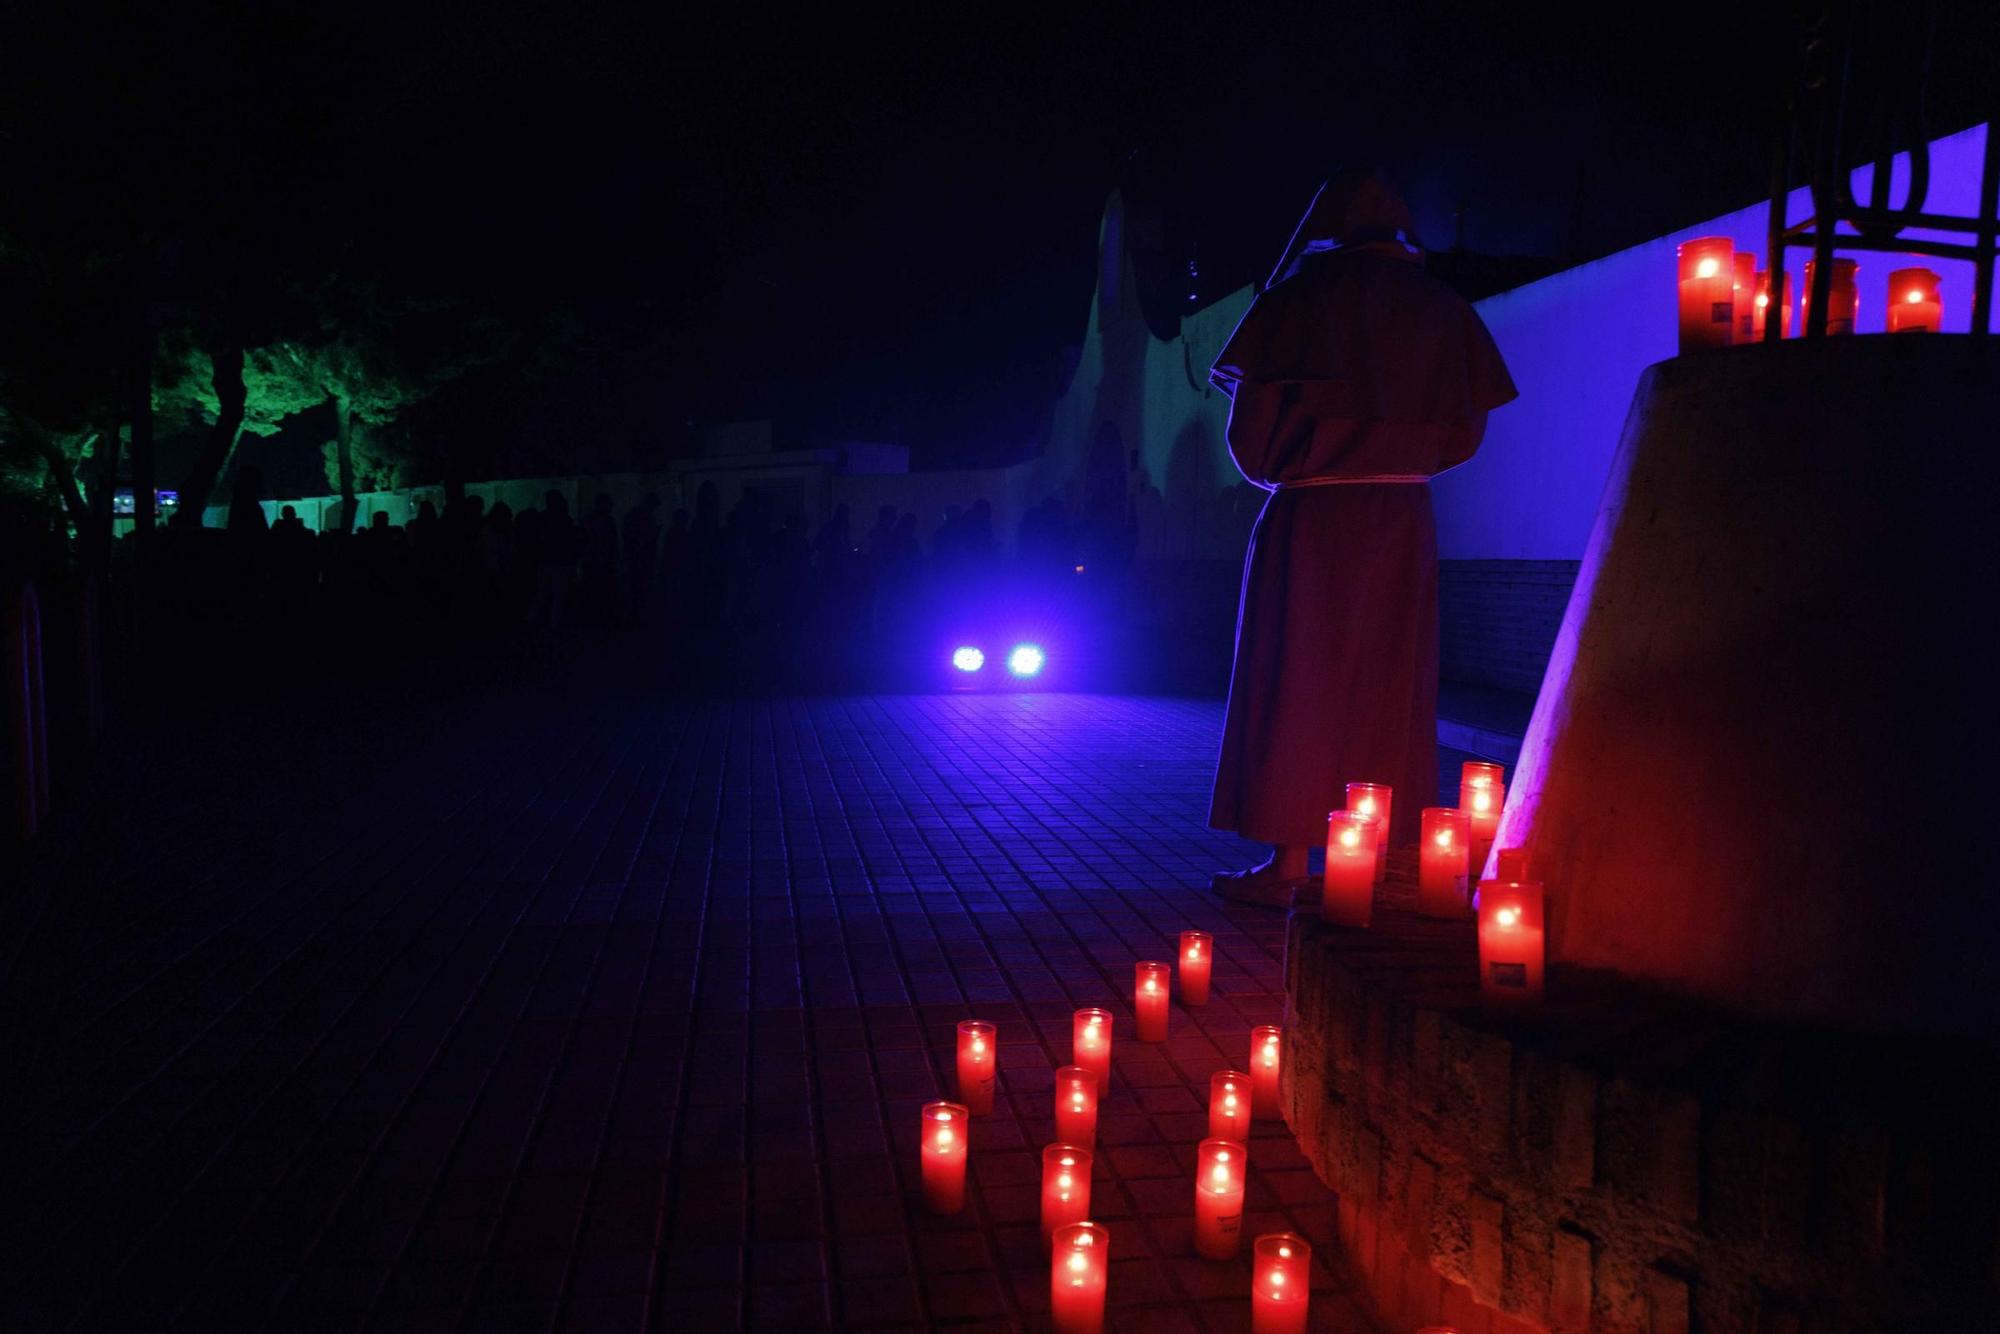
[133,474,1132,668]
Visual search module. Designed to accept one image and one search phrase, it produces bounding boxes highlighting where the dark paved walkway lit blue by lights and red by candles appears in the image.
[0,672,1408,1332]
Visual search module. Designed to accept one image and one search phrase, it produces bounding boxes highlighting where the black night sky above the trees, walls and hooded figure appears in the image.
[0,0,1992,474]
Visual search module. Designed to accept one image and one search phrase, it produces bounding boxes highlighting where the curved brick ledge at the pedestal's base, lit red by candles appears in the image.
[1284,856,2000,1334]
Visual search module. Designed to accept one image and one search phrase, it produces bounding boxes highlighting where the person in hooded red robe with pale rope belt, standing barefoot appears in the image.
[1208,172,1516,904]
